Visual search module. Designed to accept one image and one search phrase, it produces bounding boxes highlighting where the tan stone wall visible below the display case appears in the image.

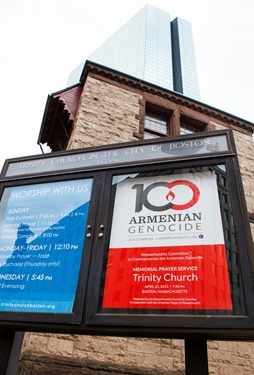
[19,333,254,375]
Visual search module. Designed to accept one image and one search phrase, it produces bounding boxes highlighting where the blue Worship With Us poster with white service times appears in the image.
[0,179,93,313]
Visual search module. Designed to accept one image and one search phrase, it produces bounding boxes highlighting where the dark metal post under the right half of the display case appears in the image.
[185,339,208,375]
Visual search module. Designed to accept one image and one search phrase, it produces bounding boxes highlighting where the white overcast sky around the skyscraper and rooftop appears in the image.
[0,0,254,168]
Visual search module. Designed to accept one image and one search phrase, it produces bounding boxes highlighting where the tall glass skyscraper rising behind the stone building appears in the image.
[68,5,199,99]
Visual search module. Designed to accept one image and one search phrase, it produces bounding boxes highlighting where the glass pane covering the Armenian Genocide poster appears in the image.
[98,165,246,316]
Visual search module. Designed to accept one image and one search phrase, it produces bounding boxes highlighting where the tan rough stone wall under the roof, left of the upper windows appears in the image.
[68,77,141,149]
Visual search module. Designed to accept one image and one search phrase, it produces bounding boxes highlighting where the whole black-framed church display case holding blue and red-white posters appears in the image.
[0,130,254,340]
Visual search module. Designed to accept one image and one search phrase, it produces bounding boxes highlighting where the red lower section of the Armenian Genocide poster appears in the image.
[102,244,232,310]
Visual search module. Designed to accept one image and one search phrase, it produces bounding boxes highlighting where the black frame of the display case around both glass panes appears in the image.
[0,130,254,340]
